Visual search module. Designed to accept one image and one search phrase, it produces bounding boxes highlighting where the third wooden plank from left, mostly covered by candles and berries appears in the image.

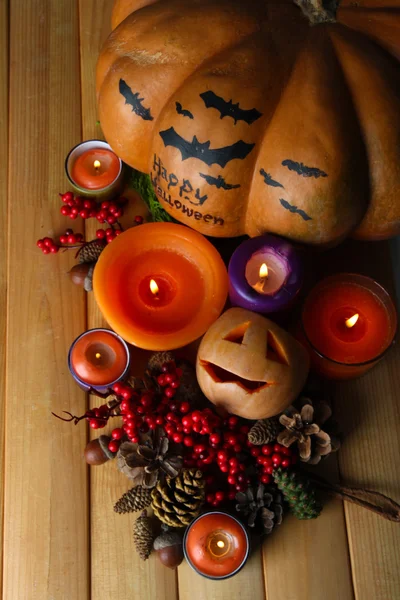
[80,0,177,600]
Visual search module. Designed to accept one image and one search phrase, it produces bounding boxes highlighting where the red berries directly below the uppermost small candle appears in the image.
[60,192,126,225]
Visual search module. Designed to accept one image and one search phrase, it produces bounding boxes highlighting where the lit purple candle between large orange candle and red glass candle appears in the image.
[228,234,303,314]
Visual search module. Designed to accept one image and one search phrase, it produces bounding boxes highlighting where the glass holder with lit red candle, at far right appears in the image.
[298,273,397,379]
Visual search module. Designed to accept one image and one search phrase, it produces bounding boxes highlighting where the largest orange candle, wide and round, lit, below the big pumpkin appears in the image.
[93,223,228,350]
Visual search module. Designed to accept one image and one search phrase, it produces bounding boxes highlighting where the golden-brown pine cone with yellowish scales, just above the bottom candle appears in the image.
[151,469,204,527]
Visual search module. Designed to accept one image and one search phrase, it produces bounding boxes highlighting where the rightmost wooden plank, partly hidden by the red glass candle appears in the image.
[320,242,400,600]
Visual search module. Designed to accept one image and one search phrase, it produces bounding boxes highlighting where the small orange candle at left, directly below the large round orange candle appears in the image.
[70,330,128,386]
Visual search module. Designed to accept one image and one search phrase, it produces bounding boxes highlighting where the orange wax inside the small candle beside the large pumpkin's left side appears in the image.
[70,148,121,190]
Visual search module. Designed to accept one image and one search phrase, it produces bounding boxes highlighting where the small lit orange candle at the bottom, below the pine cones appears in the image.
[185,512,249,579]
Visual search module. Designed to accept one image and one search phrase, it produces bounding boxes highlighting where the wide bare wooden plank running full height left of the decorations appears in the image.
[3,0,89,600]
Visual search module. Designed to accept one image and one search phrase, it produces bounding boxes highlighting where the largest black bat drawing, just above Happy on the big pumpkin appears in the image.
[160,127,255,168]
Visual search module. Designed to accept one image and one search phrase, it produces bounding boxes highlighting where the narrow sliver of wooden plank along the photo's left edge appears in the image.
[0,0,8,589]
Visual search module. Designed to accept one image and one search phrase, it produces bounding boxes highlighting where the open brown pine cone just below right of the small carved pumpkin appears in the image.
[277,398,340,465]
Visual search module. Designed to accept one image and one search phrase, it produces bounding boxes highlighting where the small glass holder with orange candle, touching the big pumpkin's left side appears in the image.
[65,140,124,201]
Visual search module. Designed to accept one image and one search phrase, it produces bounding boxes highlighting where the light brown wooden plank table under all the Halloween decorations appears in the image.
[0,0,400,600]
